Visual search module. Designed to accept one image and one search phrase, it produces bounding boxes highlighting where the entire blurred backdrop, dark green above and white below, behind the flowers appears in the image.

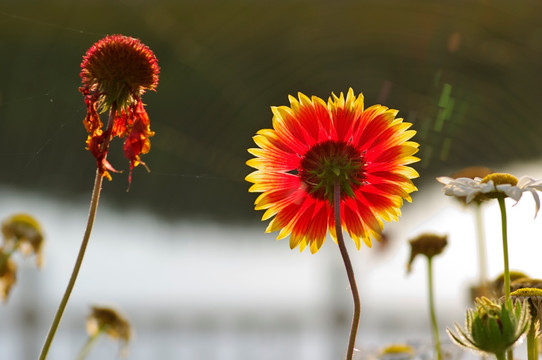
[0,0,542,360]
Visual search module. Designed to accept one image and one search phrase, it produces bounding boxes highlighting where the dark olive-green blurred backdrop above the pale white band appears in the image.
[0,0,542,220]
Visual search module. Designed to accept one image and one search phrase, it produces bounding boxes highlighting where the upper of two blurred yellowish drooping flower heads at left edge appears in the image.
[2,214,44,267]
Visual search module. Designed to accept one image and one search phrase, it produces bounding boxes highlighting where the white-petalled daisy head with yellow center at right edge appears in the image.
[437,173,542,217]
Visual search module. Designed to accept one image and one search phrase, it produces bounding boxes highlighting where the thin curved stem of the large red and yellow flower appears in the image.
[333,180,361,360]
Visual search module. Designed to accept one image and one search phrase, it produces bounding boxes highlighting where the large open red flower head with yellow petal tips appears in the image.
[246,89,419,253]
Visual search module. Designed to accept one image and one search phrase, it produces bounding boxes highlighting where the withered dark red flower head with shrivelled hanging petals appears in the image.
[79,35,160,181]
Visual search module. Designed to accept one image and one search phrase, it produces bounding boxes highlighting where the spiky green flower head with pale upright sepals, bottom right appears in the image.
[447,297,531,359]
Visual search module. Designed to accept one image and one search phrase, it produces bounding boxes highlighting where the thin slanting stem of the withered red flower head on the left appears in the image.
[39,104,117,360]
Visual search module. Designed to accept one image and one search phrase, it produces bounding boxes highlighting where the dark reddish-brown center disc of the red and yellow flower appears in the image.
[298,140,365,201]
